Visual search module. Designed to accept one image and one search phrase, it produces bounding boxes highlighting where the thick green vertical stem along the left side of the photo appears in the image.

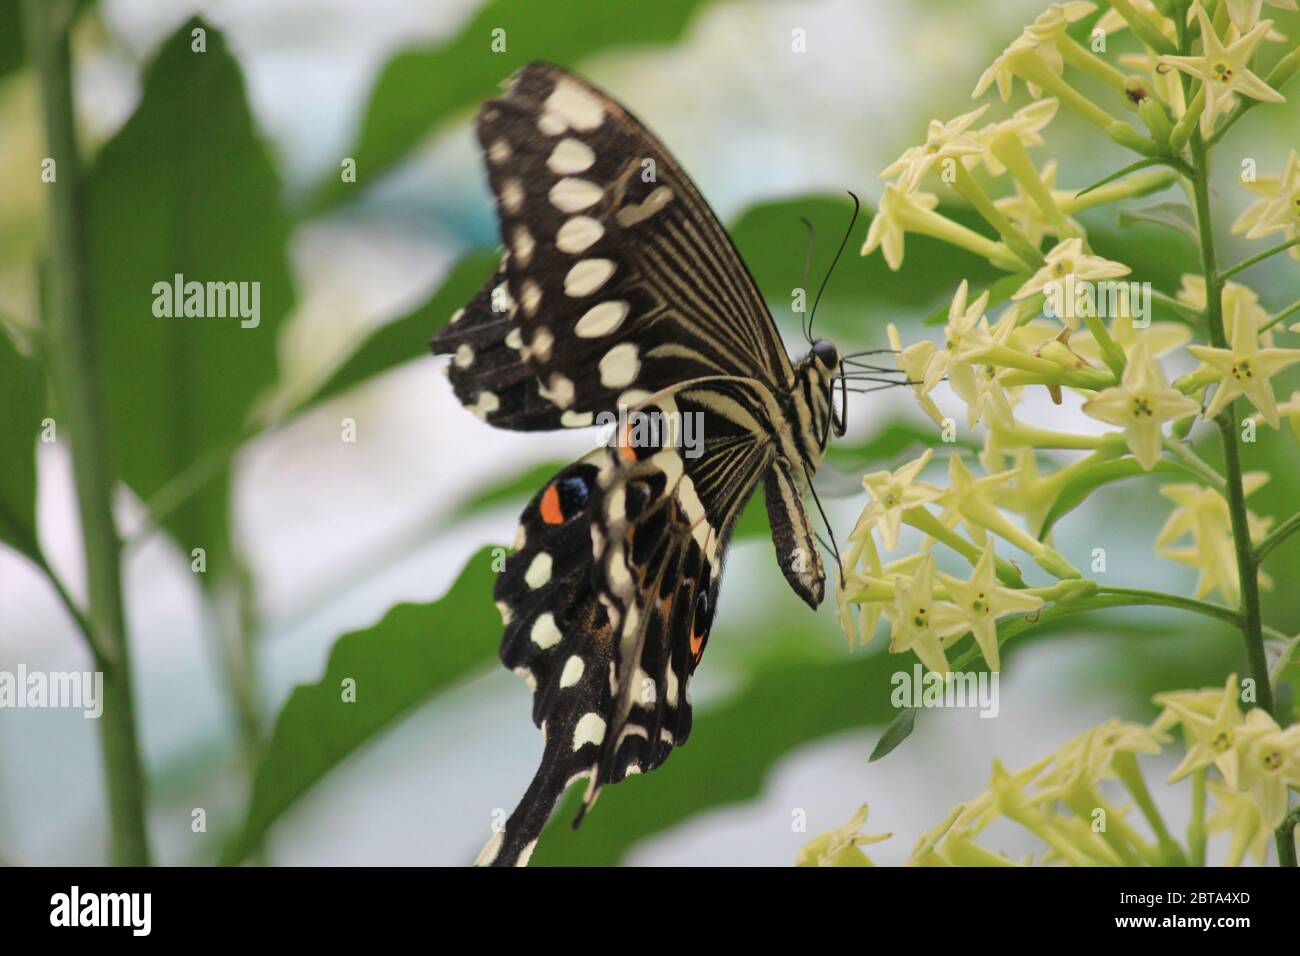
[22,0,150,866]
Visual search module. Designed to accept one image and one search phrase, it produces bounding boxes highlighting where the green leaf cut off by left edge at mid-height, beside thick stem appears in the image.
[0,326,46,563]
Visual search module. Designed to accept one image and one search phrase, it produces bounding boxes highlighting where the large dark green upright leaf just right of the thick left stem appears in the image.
[87,20,294,580]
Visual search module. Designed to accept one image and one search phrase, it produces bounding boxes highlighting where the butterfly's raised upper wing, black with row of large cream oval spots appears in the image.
[434,64,793,428]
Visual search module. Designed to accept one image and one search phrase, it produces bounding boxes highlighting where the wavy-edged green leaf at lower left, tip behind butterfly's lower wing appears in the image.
[221,548,501,865]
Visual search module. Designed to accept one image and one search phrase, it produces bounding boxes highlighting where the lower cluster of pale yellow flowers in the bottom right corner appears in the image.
[800,674,1300,866]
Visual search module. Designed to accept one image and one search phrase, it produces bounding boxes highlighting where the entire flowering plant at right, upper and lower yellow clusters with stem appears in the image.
[832,0,1300,865]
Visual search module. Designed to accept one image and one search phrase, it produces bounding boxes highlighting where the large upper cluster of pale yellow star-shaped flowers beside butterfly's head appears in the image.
[837,0,1300,672]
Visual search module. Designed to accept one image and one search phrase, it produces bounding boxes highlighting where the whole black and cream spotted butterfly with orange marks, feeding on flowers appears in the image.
[433,64,878,865]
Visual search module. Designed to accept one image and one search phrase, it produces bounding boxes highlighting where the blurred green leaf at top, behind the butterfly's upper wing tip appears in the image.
[308,0,707,212]
